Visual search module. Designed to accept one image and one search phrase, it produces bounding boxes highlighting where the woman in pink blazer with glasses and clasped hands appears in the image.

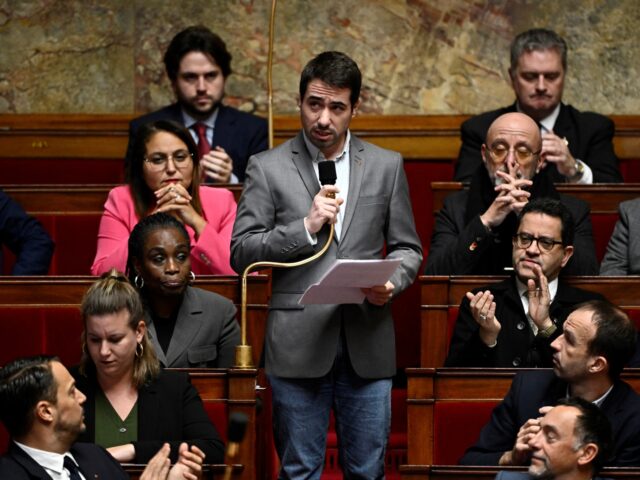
[91,120,236,275]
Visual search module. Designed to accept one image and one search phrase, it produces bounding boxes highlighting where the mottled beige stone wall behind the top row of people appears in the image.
[0,0,640,114]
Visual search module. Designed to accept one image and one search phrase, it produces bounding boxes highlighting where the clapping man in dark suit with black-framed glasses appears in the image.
[445,198,602,368]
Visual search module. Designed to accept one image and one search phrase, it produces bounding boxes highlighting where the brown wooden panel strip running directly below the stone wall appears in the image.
[0,114,640,162]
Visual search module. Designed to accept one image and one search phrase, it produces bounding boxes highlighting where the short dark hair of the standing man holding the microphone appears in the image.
[300,51,362,108]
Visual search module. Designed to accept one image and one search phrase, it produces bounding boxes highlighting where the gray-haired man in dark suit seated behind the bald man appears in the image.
[454,28,622,184]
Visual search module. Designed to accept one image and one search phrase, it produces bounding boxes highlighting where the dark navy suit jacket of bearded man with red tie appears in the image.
[125,103,269,182]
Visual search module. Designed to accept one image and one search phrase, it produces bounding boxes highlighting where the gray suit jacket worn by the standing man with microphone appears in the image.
[231,132,422,378]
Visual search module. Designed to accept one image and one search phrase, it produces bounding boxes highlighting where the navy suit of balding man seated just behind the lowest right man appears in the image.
[460,369,640,467]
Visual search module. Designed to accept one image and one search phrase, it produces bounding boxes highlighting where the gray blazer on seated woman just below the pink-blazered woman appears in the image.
[145,287,240,368]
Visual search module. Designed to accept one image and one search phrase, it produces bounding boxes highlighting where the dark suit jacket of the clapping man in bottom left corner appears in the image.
[0,442,129,480]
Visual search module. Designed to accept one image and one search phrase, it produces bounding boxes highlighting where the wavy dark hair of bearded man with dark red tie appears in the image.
[164,25,231,82]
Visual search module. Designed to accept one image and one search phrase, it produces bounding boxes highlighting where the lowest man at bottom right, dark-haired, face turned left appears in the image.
[496,397,613,480]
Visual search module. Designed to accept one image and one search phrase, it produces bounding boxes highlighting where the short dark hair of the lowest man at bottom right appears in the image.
[558,397,613,474]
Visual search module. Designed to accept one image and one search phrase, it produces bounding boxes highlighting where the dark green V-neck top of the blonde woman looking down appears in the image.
[95,389,138,448]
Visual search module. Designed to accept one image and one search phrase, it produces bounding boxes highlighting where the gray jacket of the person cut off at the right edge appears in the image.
[600,198,640,275]
